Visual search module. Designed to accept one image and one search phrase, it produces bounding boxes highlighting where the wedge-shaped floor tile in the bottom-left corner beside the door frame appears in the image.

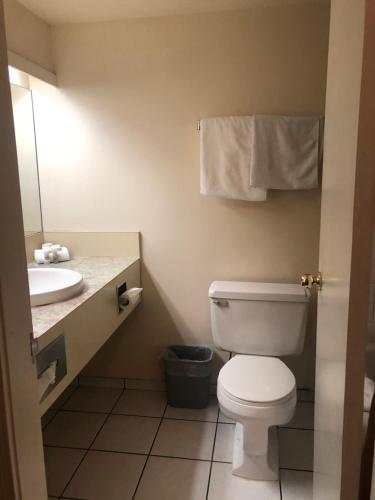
[44,447,85,497]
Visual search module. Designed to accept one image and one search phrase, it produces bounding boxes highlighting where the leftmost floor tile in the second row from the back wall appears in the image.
[43,411,106,448]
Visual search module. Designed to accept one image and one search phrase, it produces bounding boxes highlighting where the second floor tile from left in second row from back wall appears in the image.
[92,415,160,454]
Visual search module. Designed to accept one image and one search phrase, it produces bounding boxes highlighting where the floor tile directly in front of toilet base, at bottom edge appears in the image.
[208,463,280,500]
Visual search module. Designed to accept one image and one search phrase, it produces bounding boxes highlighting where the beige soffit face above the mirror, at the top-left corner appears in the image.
[4,0,54,71]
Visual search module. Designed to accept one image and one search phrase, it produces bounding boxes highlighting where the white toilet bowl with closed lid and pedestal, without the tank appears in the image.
[217,355,296,481]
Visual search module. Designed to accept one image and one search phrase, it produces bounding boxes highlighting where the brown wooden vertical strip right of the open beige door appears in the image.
[341,0,375,500]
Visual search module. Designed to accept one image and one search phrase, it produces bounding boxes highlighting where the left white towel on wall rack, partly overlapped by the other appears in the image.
[200,116,267,201]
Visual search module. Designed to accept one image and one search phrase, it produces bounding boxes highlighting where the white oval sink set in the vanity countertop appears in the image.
[27,267,83,306]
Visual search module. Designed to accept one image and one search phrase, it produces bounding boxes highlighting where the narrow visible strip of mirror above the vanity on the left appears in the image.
[11,84,42,236]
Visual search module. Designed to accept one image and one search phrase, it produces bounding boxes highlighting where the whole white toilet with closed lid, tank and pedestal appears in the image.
[209,281,310,480]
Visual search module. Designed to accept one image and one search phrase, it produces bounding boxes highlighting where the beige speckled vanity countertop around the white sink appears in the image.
[29,257,139,338]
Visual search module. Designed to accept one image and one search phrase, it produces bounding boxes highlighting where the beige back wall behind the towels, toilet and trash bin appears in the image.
[36,2,329,385]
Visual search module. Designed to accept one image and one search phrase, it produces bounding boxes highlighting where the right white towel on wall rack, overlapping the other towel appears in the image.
[250,115,323,189]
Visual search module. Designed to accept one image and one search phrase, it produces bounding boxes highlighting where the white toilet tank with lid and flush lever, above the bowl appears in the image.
[208,281,310,356]
